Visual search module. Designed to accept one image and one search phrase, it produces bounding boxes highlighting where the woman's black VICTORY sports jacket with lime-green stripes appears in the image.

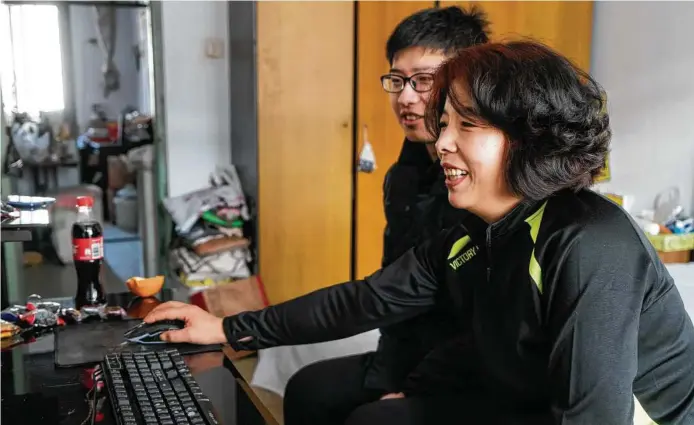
[224,191,694,425]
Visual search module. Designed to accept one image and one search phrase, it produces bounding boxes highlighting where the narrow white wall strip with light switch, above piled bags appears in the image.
[161,1,231,196]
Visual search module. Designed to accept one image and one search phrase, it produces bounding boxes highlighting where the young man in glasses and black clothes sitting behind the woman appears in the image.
[284,7,488,425]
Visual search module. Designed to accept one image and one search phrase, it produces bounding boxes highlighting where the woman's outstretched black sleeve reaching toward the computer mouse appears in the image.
[224,234,441,350]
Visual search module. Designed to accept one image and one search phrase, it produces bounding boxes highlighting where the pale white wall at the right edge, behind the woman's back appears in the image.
[592,1,694,213]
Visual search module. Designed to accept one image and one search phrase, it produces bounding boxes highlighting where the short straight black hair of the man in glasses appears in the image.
[386,6,489,64]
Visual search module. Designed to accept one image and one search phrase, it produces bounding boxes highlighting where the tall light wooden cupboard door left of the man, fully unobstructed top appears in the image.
[256,2,354,304]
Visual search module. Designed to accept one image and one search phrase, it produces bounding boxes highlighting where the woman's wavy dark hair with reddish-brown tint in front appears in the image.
[425,40,612,199]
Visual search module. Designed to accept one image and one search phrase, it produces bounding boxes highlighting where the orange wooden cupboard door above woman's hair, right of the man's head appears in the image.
[441,1,593,70]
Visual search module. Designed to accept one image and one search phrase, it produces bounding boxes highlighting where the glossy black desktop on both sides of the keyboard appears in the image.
[0,293,258,425]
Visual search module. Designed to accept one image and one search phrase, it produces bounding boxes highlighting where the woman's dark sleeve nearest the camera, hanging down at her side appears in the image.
[542,232,657,425]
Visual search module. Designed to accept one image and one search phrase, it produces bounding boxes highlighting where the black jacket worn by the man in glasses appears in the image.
[364,140,468,392]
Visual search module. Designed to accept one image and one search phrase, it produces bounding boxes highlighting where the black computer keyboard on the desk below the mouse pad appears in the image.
[102,349,219,425]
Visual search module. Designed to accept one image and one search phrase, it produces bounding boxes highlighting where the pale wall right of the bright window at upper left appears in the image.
[69,5,145,131]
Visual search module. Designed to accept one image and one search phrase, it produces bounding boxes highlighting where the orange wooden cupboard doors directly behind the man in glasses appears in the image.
[355,1,593,278]
